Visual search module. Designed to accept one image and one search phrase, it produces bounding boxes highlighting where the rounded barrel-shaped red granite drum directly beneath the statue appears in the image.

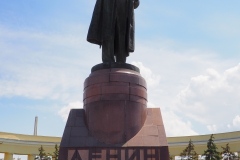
[83,64,147,144]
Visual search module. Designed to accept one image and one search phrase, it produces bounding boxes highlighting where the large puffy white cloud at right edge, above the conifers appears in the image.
[175,64,240,132]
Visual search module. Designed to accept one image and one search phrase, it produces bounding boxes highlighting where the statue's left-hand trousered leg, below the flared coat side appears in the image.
[102,37,115,63]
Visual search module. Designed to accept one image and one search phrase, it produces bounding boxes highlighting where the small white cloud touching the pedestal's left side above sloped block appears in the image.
[58,101,83,122]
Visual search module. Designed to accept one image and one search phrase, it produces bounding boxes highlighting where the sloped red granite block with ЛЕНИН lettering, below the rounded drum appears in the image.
[59,108,169,160]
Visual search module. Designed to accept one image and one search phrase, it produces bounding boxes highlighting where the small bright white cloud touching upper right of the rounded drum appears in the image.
[131,62,160,87]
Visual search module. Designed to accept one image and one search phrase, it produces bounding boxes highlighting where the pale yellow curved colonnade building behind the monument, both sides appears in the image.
[0,131,240,160]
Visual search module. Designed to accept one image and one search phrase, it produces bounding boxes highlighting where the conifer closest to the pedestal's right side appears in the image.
[180,139,198,160]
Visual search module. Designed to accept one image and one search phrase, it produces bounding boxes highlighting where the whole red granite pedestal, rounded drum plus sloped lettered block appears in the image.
[59,64,169,160]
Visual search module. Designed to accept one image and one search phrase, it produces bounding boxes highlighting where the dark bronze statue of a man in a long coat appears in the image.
[87,0,139,63]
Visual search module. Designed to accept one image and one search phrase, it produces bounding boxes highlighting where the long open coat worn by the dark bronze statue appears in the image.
[87,0,139,56]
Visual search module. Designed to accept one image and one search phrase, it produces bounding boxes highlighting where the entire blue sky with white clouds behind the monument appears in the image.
[0,0,240,137]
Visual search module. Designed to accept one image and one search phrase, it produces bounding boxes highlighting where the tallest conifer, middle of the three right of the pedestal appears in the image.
[203,134,221,160]
